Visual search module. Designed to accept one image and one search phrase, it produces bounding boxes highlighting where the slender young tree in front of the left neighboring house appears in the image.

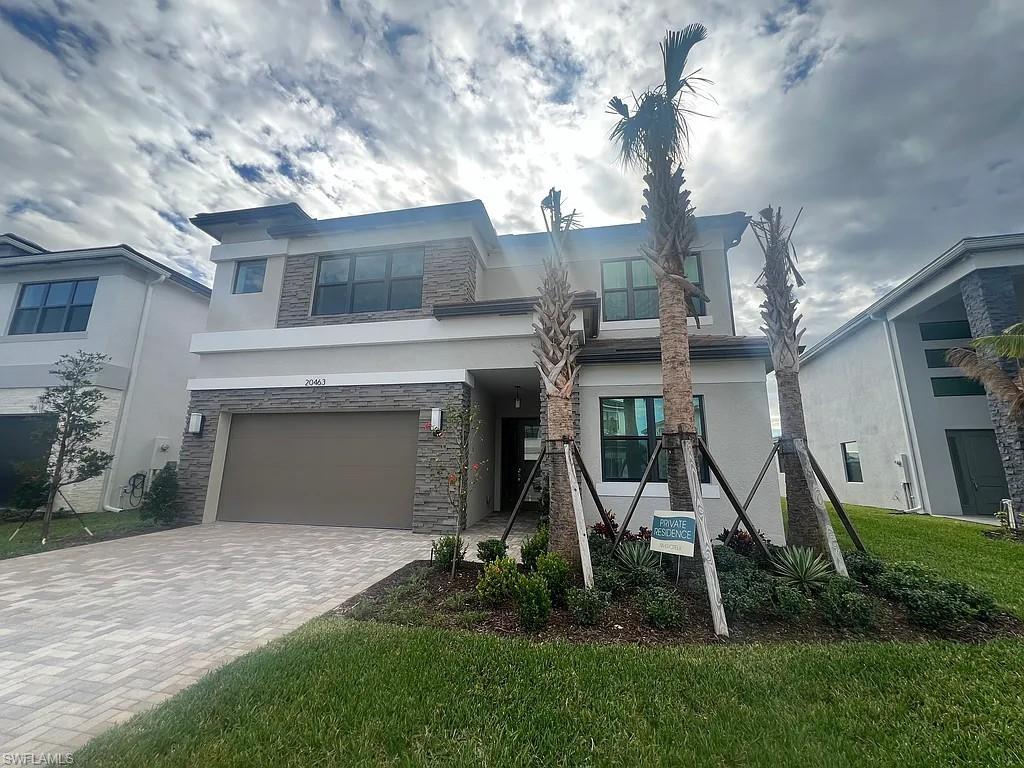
[39,350,114,544]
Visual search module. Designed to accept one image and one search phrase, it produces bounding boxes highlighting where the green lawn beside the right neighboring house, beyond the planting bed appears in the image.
[833,505,1024,618]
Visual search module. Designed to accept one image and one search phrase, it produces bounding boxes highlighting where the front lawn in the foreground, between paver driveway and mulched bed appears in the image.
[75,620,1024,768]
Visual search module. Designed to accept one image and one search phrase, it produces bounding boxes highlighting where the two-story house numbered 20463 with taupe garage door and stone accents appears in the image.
[181,201,783,542]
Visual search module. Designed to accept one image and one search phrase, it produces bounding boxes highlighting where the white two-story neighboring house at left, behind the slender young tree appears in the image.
[0,233,210,512]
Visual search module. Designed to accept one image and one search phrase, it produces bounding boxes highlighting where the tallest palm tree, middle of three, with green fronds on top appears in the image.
[608,24,708,565]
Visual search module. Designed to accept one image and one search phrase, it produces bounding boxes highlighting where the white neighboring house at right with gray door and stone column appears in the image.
[800,234,1024,515]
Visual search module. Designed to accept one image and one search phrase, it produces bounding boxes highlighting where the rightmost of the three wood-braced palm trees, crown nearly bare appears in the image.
[751,206,824,552]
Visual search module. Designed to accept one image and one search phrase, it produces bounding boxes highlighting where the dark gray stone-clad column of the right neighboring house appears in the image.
[961,267,1024,514]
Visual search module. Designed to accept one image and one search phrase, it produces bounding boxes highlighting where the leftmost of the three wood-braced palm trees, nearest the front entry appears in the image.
[534,187,582,571]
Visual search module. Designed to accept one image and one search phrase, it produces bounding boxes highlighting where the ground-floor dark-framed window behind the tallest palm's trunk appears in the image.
[601,395,711,483]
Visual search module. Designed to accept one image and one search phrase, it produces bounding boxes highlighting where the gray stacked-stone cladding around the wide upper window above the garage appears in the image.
[278,238,477,328]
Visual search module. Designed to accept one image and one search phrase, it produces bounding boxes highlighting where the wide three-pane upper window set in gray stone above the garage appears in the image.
[312,248,423,314]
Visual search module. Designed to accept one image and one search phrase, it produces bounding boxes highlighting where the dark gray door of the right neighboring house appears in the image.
[946,429,1010,515]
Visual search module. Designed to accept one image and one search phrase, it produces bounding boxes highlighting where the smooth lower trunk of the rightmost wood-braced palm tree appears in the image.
[775,371,824,552]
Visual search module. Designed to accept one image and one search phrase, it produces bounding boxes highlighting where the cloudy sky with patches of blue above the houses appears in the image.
[0,0,1024,348]
